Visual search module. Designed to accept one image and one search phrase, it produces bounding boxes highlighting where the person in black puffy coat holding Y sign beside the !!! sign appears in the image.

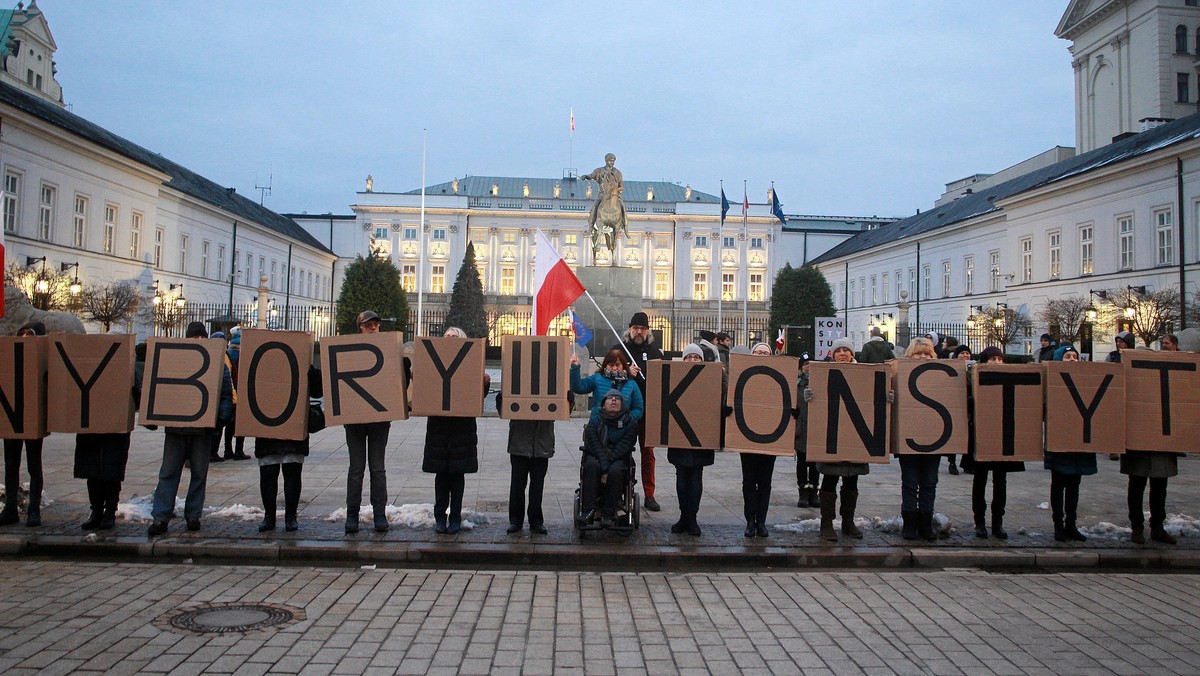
[421,327,492,536]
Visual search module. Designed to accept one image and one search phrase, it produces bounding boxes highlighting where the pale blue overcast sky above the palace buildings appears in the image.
[38,0,1074,216]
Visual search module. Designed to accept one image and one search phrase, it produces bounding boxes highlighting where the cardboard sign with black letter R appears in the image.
[320,331,408,425]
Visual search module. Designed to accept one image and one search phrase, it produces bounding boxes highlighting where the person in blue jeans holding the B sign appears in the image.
[146,322,233,538]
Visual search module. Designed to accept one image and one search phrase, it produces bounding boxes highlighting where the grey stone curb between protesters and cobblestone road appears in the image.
[0,534,1200,570]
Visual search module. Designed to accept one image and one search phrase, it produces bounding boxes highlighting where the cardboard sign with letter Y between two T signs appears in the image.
[1045,361,1132,453]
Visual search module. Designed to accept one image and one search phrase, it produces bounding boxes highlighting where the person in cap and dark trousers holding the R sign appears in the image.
[343,310,391,533]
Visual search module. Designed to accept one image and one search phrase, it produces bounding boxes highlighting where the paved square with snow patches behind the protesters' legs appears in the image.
[0,417,1200,551]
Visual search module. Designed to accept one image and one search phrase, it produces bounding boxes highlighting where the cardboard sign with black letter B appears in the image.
[138,336,224,427]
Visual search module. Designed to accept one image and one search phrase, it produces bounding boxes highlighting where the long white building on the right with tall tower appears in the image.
[815,0,1200,354]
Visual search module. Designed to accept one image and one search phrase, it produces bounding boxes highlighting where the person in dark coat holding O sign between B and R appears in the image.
[254,366,322,533]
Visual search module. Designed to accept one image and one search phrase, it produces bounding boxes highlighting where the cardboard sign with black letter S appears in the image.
[892,359,970,455]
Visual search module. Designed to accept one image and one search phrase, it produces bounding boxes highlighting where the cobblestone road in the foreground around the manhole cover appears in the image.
[0,561,1200,675]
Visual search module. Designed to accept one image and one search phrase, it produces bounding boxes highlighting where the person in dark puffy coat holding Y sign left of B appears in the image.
[74,331,145,531]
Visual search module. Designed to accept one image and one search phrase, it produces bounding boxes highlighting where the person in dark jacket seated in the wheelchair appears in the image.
[576,389,637,528]
